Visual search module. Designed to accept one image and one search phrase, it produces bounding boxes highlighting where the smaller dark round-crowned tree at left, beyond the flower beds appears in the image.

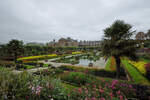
[7,40,24,63]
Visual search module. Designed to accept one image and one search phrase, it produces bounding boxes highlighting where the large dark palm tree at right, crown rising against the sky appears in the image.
[102,20,137,78]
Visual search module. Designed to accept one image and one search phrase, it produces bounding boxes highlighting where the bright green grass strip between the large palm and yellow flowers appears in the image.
[122,59,150,85]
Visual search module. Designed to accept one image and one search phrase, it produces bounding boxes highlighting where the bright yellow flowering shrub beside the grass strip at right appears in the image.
[129,60,146,75]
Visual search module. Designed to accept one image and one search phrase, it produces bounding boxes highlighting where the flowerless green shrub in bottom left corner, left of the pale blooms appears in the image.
[0,70,32,100]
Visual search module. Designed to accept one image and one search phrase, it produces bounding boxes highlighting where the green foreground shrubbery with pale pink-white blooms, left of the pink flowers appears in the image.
[0,70,67,100]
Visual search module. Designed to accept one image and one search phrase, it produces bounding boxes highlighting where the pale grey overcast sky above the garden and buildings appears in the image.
[0,0,150,43]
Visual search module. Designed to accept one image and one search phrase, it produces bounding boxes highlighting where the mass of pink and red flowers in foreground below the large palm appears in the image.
[68,79,135,100]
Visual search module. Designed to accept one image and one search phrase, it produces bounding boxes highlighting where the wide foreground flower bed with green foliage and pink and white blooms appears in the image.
[0,68,148,100]
